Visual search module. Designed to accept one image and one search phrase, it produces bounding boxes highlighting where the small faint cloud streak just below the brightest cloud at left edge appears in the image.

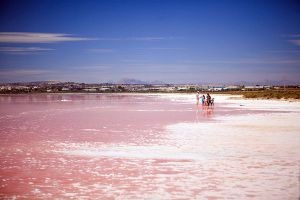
[0,47,54,54]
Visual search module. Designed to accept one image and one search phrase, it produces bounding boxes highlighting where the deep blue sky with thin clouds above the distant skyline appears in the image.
[0,0,300,84]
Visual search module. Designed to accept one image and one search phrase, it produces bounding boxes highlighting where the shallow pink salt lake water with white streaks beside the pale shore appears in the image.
[0,94,297,199]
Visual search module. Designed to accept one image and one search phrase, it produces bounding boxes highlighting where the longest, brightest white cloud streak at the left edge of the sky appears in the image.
[0,32,96,43]
